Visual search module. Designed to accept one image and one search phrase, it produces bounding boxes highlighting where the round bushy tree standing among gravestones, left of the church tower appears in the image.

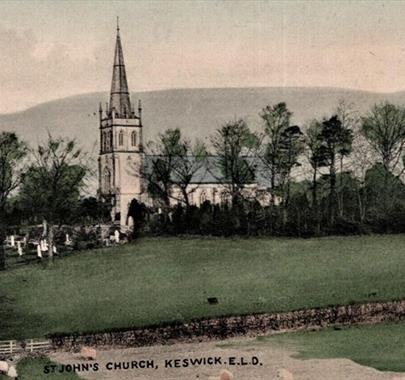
[20,136,90,257]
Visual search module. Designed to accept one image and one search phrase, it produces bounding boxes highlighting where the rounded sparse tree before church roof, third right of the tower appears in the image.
[211,119,258,202]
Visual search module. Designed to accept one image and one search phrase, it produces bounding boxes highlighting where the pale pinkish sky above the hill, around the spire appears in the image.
[0,0,405,113]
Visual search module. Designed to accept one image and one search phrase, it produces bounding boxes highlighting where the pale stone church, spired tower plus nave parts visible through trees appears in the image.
[98,25,269,229]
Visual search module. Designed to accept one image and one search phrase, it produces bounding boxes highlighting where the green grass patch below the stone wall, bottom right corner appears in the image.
[257,321,405,372]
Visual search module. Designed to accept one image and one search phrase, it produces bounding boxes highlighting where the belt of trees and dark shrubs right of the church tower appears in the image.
[138,102,405,236]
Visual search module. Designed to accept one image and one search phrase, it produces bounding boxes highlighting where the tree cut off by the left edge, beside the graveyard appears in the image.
[0,132,28,269]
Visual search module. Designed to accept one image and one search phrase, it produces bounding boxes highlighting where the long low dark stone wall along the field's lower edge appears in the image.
[50,300,405,350]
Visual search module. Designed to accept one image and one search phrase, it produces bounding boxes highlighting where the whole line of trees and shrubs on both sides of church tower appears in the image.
[0,102,405,249]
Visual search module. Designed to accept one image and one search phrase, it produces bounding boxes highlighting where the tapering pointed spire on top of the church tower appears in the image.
[110,17,131,118]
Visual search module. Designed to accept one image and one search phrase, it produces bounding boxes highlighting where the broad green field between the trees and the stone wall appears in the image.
[0,235,405,339]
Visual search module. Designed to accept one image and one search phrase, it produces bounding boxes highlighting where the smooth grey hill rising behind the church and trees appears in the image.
[0,87,405,152]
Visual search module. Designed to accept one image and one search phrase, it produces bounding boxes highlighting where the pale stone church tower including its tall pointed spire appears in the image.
[98,24,143,229]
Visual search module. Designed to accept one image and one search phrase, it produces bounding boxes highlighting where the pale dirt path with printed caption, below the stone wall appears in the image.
[50,338,405,380]
